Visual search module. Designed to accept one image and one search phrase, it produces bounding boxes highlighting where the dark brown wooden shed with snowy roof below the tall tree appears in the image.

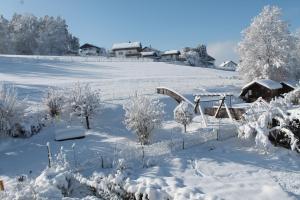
[240,79,294,103]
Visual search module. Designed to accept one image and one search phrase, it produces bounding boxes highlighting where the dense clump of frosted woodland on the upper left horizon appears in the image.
[0,14,79,55]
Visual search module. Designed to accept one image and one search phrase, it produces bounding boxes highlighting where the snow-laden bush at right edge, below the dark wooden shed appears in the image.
[239,89,300,152]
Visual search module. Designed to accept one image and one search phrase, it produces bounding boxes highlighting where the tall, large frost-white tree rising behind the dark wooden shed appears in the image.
[238,6,295,81]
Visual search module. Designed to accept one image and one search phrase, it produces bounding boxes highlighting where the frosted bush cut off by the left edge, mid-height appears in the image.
[0,84,25,136]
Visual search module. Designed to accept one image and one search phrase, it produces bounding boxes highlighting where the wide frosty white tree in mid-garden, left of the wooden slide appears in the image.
[123,94,164,145]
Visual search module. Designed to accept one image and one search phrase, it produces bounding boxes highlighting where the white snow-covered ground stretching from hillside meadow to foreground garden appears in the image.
[0,56,300,200]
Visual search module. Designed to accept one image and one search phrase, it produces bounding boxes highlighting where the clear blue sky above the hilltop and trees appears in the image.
[0,0,300,63]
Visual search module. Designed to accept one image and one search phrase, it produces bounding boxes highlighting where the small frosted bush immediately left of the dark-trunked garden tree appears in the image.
[43,88,66,117]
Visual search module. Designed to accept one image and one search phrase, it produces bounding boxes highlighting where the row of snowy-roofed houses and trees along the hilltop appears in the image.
[79,42,237,71]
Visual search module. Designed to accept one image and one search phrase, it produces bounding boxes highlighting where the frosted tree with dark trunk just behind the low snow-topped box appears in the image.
[67,83,101,129]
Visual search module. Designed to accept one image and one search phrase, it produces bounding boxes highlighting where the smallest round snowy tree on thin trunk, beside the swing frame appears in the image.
[174,101,194,133]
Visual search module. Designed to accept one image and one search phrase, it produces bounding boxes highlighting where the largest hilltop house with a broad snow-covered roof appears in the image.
[112,42,142,57]
